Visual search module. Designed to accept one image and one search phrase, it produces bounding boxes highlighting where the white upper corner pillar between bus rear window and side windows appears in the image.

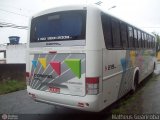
[86,7,105,51]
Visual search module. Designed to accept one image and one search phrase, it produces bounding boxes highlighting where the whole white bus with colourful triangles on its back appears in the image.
[26,6,156,112]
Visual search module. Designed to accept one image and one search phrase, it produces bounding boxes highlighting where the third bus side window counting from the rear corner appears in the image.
[120,22,128,49]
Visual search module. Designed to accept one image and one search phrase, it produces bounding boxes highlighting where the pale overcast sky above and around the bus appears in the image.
[0,0,160,44]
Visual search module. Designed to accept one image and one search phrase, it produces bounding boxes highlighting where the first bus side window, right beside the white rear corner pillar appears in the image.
[101,14,112,48]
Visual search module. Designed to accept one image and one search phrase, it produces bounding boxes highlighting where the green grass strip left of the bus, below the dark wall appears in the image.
[0,80,26,95]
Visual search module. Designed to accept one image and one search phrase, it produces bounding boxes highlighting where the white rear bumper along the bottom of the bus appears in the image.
[27,86,101,112]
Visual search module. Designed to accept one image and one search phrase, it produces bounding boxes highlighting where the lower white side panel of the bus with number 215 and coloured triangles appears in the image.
[103,49,155,106]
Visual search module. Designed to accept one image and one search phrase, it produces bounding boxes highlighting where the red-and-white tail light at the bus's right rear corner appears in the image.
[86,77,99,95]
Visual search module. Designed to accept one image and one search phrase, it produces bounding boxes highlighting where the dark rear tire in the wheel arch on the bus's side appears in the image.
[131,71,139,93]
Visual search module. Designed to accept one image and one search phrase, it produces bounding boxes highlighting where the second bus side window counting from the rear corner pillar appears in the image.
[111,18,122,48]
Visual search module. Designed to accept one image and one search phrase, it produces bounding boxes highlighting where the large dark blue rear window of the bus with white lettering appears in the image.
[30,10,86,42]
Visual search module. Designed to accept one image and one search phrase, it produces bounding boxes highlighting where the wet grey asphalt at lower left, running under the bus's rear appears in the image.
[0,90,107,120]
